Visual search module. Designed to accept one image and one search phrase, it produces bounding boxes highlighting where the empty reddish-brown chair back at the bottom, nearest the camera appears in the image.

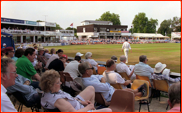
[109,90,135,112]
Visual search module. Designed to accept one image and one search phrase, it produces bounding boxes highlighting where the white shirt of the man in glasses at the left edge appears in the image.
[1,84,17,112]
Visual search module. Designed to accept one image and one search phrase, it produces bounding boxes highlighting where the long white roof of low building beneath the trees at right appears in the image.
[132,33,169,38]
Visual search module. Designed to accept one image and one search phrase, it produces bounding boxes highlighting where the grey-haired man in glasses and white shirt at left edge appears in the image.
[1,58,18,112]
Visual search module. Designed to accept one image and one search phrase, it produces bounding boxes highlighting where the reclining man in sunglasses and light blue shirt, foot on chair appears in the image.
[78,61,147,102]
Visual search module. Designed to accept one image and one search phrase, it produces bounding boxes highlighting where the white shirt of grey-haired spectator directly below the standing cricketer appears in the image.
[116,62,136,80]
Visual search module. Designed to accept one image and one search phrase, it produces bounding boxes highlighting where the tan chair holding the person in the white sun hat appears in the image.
[152,79,169,110]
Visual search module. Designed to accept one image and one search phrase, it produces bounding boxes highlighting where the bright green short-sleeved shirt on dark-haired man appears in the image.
[16,55,37,81]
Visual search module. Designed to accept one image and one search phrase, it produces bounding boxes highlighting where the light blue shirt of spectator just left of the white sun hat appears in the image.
[134,62,154,79]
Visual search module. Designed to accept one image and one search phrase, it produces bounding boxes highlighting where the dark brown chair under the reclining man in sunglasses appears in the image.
[95,92,110,107]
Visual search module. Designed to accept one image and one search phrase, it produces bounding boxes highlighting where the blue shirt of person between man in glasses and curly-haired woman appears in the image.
[7,75,37,100]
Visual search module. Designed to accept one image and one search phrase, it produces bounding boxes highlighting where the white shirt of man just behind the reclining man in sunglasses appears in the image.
[103,71,127,89]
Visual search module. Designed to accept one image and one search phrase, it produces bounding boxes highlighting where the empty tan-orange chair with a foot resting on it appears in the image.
[131,79,150,112]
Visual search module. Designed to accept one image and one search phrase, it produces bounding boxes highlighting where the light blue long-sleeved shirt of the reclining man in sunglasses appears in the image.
[82,75,115,102]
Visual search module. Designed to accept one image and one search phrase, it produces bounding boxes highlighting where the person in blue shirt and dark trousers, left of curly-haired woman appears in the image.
[7,75,41,109]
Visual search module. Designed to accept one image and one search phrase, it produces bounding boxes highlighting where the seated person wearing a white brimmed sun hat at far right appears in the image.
[151,62,181,86]
